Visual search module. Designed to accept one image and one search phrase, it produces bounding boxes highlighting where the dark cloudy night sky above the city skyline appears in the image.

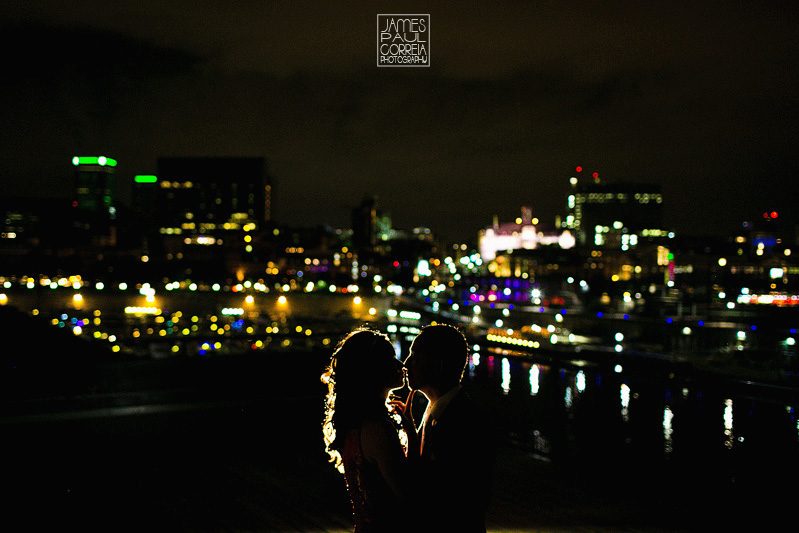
[0,0,799,240]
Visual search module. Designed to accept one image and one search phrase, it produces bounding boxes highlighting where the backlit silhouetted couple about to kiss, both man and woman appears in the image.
[323,325,494,533]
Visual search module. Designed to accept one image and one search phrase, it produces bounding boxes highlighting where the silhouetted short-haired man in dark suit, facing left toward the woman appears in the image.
[405,325,494,533]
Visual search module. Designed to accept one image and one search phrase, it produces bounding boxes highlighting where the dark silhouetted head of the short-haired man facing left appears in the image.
[405,325,468,394]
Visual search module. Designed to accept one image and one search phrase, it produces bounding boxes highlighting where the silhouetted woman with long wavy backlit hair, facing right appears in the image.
[322,329,418,533]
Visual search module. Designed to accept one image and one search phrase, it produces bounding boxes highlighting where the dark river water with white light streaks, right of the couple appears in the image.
[466,345,799,526]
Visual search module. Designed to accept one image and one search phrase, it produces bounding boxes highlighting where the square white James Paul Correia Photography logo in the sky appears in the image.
[377,14,430,67]
